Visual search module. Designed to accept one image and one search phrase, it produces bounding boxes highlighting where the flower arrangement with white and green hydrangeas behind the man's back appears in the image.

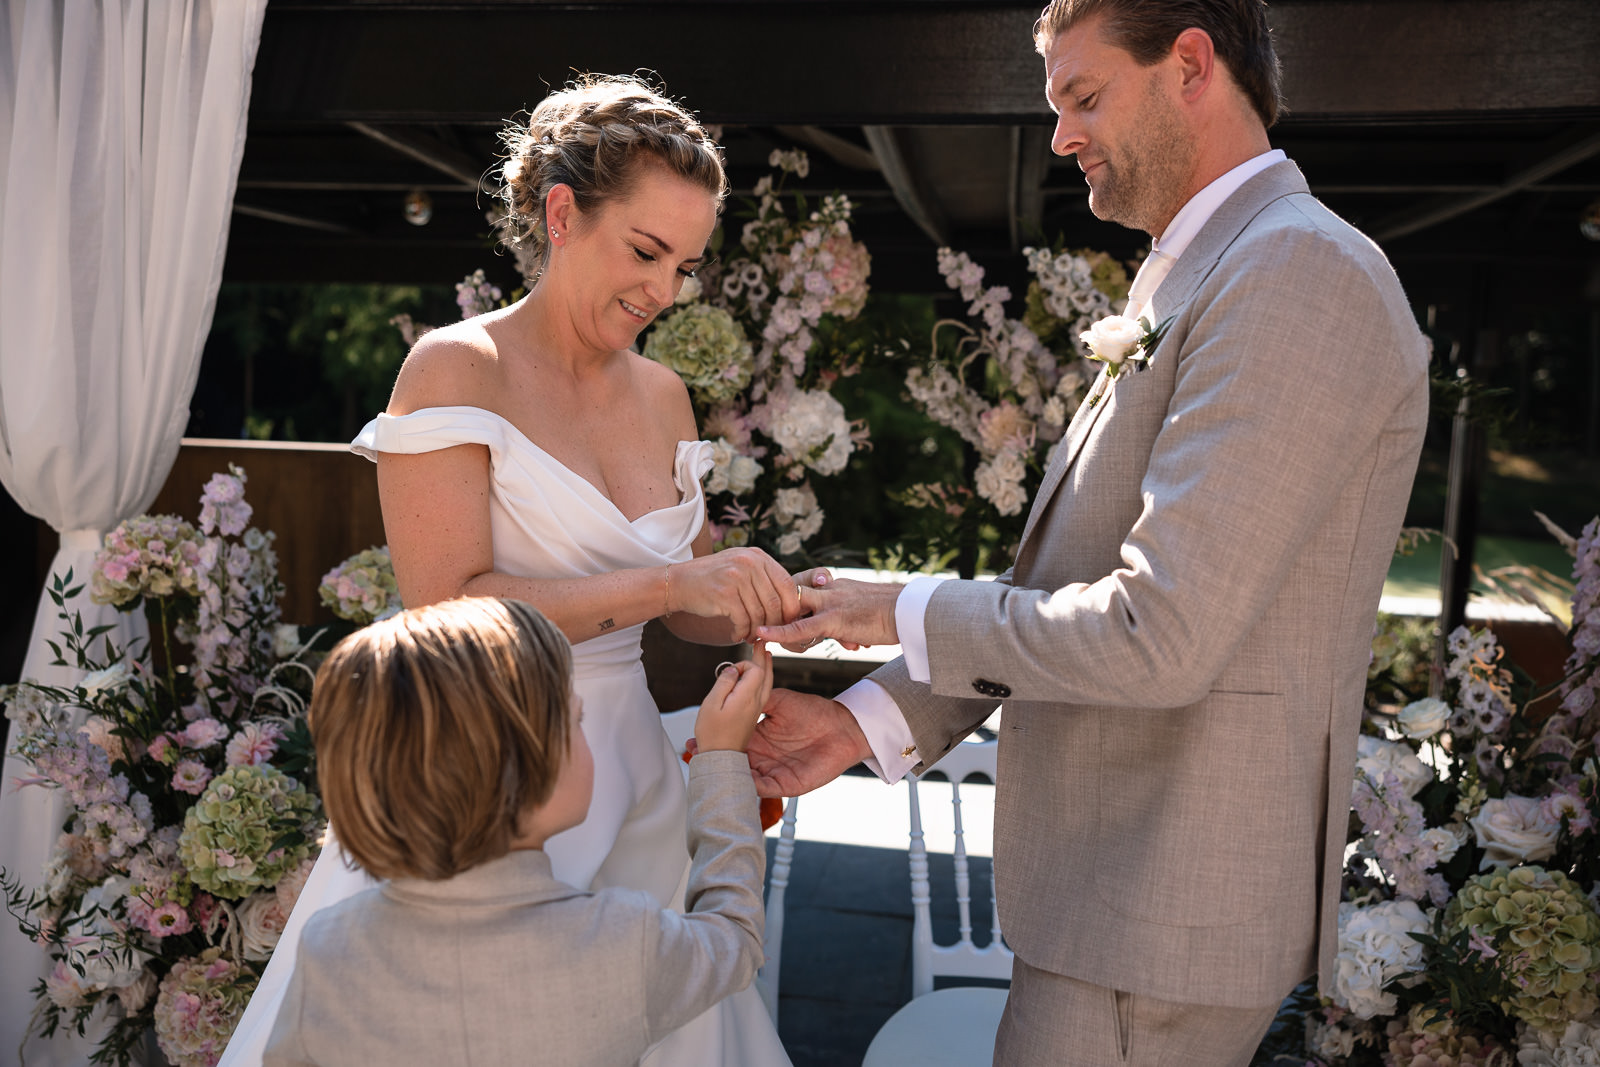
[1306,518,1600,1067]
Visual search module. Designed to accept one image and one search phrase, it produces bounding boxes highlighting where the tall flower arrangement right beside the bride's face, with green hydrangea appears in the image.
[643,152,872,557]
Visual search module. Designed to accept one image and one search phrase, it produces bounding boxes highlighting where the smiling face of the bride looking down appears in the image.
[550,163,717,352]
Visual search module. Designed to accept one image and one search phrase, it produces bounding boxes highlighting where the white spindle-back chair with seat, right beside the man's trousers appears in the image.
[861,741,1013,1067]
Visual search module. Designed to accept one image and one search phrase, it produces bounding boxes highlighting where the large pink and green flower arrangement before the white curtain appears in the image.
[0,467,322,1067]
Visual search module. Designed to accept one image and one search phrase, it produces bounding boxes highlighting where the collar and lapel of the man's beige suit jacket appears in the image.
[1016,160,1310,566]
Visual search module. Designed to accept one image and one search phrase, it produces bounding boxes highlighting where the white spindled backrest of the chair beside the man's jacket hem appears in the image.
[909,741,1013,998]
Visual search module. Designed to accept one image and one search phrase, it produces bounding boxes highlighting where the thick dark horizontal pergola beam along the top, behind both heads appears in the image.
[251,0,1600,126]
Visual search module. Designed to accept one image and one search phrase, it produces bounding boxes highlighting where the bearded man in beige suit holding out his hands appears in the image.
[750,0,1427,1067]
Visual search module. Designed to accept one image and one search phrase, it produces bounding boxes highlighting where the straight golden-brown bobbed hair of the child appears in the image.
[310,597,573,880]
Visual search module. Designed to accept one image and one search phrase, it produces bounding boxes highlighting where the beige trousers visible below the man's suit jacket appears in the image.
[995,957,1278,1067]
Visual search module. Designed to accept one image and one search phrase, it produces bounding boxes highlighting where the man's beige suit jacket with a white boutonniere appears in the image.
[874,162,1427,1006]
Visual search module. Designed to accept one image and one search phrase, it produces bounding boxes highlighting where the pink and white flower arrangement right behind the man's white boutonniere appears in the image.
[896,241,1128,559]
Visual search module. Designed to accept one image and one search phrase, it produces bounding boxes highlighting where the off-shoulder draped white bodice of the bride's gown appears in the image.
[360,406,712,678]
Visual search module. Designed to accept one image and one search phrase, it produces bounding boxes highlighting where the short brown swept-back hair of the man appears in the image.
[1034,0,1285,128]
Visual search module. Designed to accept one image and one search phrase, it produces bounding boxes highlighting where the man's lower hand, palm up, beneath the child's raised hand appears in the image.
[746,689,872,797]
